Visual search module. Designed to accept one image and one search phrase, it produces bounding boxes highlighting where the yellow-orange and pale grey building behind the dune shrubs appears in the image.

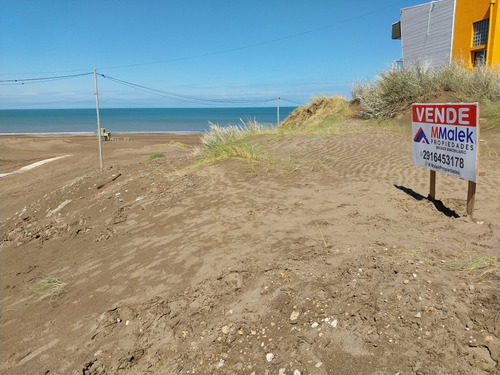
[392,0,500,68]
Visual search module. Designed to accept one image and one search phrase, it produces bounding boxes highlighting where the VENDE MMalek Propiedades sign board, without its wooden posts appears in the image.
[411,103,479,182]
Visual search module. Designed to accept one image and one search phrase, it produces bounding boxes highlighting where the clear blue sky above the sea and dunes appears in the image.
[0,0,427,109]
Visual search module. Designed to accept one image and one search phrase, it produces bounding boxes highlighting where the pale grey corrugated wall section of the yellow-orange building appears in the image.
[401,0,455,68]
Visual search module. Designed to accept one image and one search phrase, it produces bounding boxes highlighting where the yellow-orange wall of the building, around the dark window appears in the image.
[452,0,500,67]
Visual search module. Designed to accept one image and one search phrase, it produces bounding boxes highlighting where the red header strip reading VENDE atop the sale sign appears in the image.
[411,104,477,126]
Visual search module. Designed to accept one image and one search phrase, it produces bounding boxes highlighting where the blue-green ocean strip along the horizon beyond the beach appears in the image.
[0,107,295,135]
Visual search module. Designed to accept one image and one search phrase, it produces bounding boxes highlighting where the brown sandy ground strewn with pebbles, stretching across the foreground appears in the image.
[0,128,500,375]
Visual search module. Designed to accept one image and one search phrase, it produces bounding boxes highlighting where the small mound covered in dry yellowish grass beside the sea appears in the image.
[280,96,351,129]
